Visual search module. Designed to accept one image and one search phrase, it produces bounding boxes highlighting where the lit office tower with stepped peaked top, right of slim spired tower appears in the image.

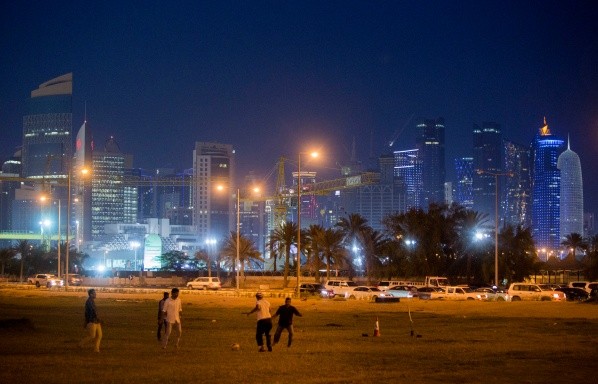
[91,137,132,240]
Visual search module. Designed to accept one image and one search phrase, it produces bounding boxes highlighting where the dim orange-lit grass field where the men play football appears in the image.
[0,288,598,384]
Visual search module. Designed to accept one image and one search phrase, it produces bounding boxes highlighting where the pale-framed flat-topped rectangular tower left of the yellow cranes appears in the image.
[193,142,236,241]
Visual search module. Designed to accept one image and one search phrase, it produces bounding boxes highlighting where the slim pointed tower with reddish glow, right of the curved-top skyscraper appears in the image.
[71,120,93,244]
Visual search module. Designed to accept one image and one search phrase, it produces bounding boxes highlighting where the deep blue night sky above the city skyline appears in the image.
[0,0,598,213]
